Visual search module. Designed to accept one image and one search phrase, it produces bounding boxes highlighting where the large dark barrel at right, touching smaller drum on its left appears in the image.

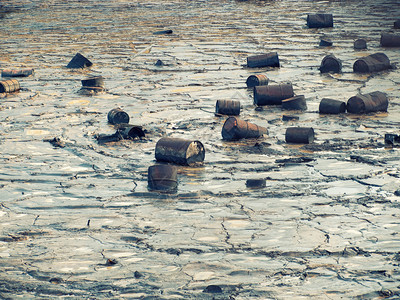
[347,91,389,114]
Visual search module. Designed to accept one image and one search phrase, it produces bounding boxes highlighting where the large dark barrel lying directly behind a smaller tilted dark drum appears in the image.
[253,83,294,106]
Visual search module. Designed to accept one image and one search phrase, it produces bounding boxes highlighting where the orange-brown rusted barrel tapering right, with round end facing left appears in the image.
[221,117,268,141]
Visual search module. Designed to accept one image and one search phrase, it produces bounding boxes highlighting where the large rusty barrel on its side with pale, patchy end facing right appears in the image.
[155,137,205,166]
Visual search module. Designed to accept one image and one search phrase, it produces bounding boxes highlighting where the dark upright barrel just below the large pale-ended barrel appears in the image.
[147,165,178,191]
